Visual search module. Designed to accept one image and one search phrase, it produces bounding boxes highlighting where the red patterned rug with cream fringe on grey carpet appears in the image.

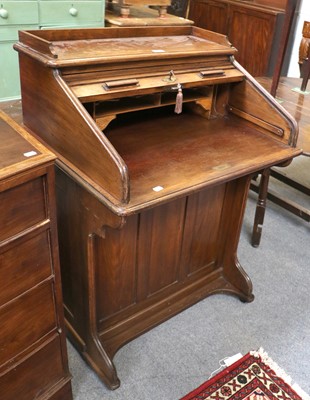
[181,349,310,400]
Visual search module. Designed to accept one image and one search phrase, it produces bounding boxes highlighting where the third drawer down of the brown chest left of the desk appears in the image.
[0,281,57,366]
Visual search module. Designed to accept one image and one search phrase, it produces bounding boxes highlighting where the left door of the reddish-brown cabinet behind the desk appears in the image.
[189,0,228,35]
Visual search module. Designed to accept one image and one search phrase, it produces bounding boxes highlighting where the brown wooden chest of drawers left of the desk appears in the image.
[0,111,72,400]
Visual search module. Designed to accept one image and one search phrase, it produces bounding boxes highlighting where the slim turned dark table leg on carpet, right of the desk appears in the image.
[252,168,270,247]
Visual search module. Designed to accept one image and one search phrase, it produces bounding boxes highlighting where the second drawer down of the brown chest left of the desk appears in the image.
[0,231,52,306]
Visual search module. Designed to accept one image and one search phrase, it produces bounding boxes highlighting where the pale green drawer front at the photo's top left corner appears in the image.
[0,1,39,26]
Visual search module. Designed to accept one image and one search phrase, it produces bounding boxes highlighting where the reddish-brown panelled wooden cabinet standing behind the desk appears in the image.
[188,0,286,76]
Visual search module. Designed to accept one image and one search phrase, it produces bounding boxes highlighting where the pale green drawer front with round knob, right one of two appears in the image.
[39,1,103,26]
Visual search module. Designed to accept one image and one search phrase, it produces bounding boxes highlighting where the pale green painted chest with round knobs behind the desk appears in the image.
[0,0,104,101]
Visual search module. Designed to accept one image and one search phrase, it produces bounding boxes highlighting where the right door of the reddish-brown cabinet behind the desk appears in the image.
[228,6,276,76]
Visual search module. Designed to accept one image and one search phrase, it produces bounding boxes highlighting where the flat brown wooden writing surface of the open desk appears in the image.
[105,109,299,210]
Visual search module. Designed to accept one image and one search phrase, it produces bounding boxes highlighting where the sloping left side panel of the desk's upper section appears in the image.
[20,54,128,203]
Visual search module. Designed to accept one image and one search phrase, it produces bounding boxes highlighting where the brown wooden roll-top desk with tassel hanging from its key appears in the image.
[16,26,300,388]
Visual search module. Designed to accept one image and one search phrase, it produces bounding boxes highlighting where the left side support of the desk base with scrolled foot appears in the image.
[56,168,121,390]
